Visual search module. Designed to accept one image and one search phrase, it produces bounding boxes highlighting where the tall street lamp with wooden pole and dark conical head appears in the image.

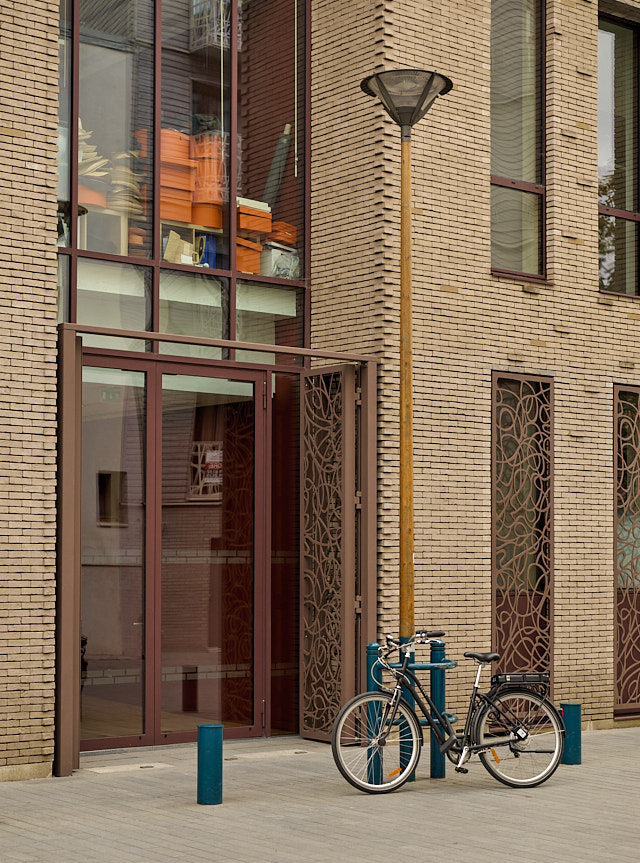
[360,69,453,641]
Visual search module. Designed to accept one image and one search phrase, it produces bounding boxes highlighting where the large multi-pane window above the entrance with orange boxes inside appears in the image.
[58,0,307,348]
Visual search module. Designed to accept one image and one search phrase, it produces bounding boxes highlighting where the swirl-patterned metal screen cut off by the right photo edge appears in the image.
[615,389,640,713]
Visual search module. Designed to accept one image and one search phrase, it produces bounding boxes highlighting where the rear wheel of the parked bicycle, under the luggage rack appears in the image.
[474,689,564,788]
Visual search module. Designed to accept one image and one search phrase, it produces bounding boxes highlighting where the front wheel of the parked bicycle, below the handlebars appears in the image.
[331,692,422,794]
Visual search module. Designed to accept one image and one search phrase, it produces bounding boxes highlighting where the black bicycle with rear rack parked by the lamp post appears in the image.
[331,631,565,794]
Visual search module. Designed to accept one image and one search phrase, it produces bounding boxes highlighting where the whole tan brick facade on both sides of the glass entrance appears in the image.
[0,0,640,779]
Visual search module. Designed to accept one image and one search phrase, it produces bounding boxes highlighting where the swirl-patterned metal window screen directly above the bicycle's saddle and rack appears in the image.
[493,375,552,671]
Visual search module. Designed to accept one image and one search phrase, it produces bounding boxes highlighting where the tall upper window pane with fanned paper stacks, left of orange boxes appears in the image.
[78,0,153,258]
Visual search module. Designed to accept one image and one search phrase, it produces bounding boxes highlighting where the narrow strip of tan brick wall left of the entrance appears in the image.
[0,0,58,780]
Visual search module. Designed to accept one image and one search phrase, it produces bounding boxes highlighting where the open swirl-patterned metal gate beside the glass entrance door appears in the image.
[300,366,356,740]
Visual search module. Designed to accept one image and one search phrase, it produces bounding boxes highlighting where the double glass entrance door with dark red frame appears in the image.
[80,359,268,749]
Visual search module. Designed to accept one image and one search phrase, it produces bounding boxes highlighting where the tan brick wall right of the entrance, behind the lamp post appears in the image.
[312,0,640,720]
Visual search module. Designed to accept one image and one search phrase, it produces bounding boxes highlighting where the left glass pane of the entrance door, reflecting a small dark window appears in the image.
[80,368,146,739]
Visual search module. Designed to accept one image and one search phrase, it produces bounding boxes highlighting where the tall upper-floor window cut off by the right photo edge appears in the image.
[598,20,640,294]
